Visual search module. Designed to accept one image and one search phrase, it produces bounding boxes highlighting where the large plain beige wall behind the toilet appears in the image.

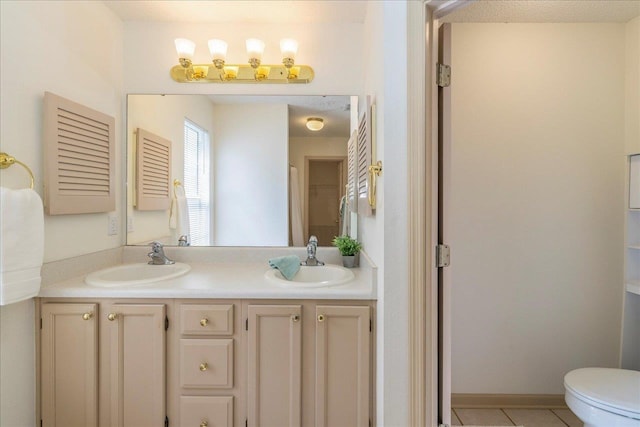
[449,24,625,394]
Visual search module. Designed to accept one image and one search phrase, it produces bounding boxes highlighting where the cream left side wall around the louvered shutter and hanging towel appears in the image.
[0,1,124,427]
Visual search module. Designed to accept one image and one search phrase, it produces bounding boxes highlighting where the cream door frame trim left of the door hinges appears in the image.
[406,0,468,426]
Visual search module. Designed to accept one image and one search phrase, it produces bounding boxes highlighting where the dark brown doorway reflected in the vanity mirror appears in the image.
[305,158,346,246]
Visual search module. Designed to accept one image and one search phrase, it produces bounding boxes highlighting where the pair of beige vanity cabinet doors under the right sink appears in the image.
[246,301,373,427]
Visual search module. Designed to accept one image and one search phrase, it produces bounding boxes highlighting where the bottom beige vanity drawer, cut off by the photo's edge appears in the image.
[180,396,233,427]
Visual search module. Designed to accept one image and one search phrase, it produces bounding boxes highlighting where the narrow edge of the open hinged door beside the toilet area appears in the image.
[438,24,451,425]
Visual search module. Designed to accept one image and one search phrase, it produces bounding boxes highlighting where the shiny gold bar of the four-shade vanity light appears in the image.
[171,64,314,84]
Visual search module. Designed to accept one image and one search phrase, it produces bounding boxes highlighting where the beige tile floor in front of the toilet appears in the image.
[451,408,583,427]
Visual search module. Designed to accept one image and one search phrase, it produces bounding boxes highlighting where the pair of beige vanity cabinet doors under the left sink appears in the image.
[40,300,166,427]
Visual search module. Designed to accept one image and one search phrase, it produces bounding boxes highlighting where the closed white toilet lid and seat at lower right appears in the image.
[564,368,640,420]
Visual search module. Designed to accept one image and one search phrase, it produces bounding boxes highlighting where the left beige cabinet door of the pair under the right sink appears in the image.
[248,305,302,427]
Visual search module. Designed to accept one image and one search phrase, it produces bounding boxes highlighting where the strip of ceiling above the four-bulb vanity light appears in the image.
[103,0,367,24]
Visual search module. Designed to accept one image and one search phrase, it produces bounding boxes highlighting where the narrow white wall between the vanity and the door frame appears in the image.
[358,1,410,426]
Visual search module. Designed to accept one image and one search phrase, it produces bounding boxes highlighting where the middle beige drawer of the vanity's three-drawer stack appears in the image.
[180,338,233,388]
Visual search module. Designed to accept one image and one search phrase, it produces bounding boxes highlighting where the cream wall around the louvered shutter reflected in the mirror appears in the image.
[126,95,218,245]
